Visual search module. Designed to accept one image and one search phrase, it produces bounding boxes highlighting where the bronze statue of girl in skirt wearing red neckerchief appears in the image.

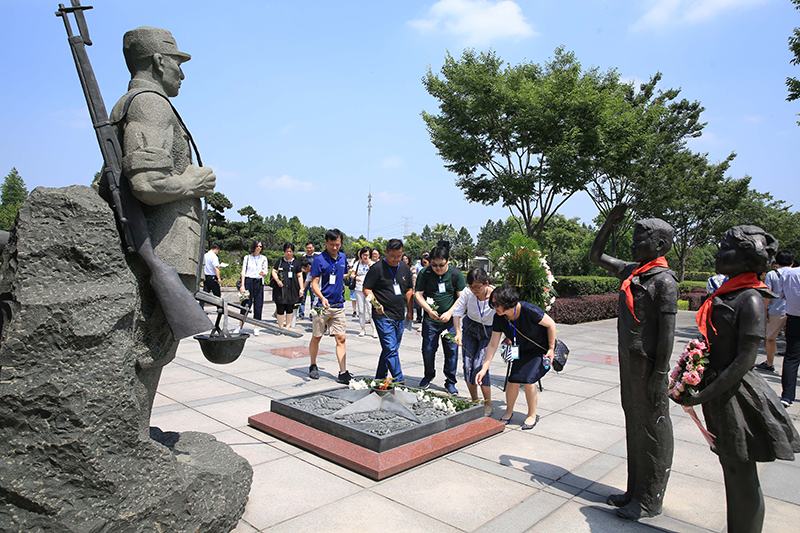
[681,226,800,533]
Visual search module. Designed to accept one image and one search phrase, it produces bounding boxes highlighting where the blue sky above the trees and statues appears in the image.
[0,0,800,238]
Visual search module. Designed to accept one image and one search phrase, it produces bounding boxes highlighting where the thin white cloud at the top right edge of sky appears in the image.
[632,0,768,31]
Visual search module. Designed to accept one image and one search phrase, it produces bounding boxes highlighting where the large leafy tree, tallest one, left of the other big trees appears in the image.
[422,47,621,238]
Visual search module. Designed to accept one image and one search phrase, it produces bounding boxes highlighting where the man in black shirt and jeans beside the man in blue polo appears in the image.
[363,239,414,381]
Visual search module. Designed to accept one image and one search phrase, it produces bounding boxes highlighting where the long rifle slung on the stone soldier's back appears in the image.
[56,0,212,340]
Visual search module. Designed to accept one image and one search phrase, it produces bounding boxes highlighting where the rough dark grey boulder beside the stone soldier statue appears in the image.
[0,186,253,533]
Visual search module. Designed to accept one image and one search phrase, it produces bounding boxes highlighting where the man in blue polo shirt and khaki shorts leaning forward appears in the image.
[308,229,353,385]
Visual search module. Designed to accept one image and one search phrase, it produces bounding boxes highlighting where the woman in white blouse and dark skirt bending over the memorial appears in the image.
[453,268,495,416]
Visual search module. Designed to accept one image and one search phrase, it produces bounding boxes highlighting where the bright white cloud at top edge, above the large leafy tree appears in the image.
[409,0,536,45]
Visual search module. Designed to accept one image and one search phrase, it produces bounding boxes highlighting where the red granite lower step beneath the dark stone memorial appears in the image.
[248,411,505,480]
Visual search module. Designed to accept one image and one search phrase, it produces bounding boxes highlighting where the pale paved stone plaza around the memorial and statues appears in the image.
[151,298,800,533]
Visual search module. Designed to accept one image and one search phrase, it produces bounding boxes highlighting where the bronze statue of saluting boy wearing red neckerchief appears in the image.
[590,205,678,520]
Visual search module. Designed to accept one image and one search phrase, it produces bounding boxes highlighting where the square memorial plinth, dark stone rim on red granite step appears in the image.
[248,389,505,480]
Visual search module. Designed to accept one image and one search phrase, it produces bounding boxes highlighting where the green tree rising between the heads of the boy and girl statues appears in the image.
[639,150,750,281]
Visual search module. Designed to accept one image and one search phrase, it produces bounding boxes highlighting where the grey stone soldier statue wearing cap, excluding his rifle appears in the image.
[109,27,216,432]
